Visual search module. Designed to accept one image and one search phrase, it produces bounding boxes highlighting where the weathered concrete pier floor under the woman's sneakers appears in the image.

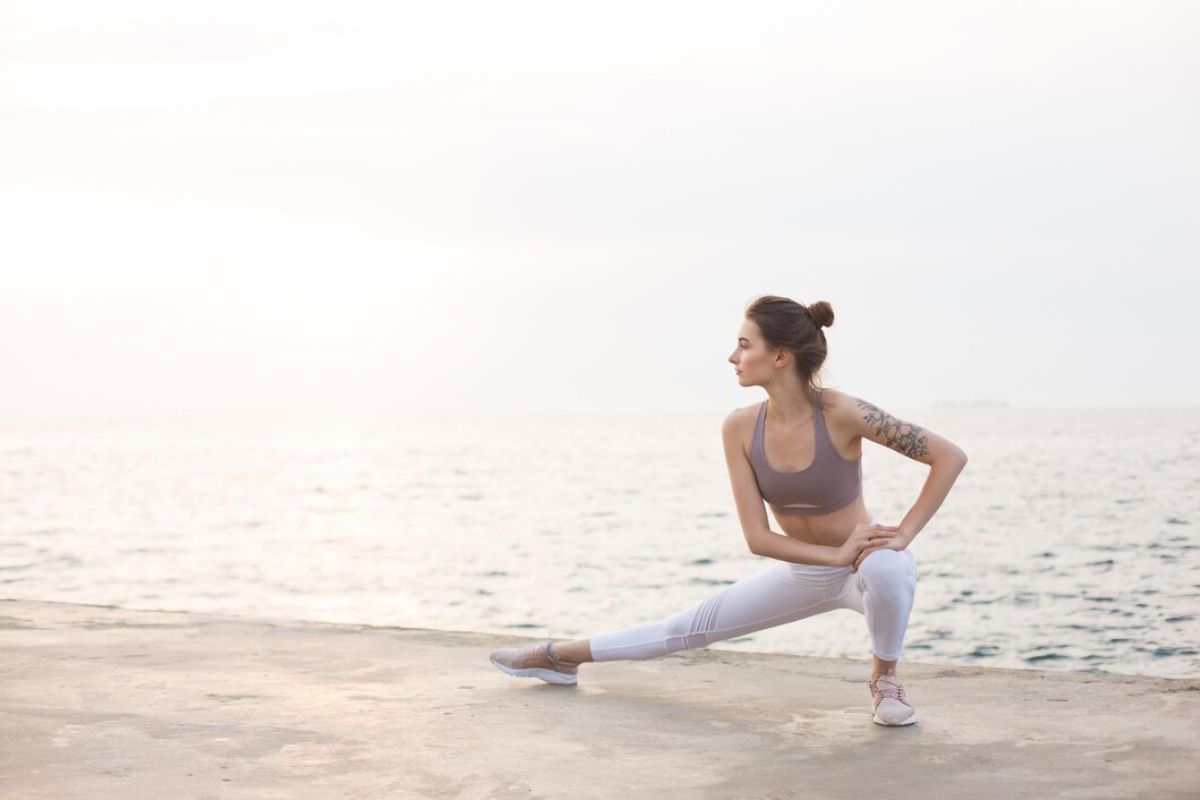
[0,600,1200,800]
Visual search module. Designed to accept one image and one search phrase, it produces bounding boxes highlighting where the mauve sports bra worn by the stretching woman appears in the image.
[750,386,863,517]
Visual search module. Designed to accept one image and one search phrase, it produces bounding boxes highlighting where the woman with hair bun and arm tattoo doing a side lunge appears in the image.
[491,295,967,726]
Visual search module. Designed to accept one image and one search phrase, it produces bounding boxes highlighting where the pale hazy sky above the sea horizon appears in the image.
[0,0,1200,422]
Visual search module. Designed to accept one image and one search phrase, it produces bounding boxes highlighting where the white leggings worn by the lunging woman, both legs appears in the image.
[588,537,917,661]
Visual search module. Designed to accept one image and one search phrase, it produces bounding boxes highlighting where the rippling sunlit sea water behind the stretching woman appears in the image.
[0,407,1200,678]
